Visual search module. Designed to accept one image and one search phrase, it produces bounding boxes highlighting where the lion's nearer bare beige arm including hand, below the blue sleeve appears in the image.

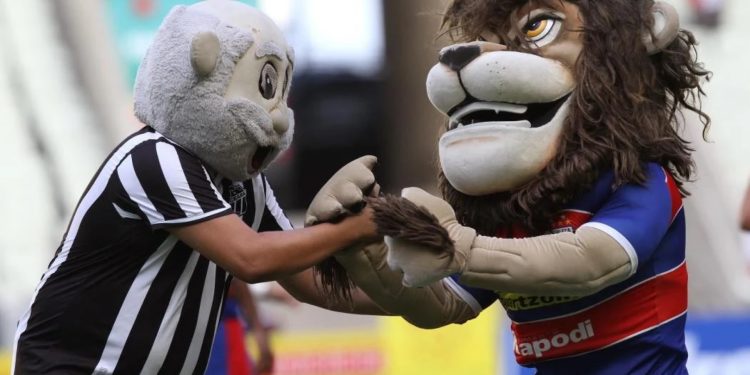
[386,188,633,296]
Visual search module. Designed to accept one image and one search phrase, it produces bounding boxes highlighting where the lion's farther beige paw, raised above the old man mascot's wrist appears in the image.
[305,155,380,226]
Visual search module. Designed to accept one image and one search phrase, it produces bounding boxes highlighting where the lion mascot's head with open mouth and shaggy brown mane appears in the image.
[427,0,709,233]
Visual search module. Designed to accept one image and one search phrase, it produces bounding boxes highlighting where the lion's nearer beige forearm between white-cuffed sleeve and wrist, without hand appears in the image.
[460,227,632,296]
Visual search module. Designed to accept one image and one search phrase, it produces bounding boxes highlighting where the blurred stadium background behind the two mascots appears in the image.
[0,0,750,375]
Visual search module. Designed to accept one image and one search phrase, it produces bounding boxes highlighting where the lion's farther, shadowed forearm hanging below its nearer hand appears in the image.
[335,241,480,329]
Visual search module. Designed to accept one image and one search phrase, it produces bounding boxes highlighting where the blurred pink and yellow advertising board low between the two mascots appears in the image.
[247,308,502,375]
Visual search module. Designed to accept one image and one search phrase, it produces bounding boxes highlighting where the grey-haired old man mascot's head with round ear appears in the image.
[134,0,294,181]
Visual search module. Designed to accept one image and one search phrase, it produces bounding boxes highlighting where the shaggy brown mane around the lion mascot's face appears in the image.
[440,0,710,235]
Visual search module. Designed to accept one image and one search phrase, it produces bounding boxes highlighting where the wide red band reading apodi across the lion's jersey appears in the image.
[511,262,687,365]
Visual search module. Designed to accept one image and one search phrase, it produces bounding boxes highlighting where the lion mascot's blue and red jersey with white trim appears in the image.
[454,163,687,374]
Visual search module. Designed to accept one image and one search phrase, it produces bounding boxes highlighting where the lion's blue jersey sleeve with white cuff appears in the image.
[584,163,681,273]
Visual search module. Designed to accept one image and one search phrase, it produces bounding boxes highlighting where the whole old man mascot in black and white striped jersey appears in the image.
[13,0,381,374]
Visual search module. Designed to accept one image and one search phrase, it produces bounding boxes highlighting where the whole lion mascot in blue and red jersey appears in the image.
[308,0,709,374]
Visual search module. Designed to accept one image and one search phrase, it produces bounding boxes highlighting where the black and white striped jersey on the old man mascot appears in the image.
[13,127,291,374]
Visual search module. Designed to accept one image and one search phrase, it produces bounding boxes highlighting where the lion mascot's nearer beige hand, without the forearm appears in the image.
[385,188,477,287]
